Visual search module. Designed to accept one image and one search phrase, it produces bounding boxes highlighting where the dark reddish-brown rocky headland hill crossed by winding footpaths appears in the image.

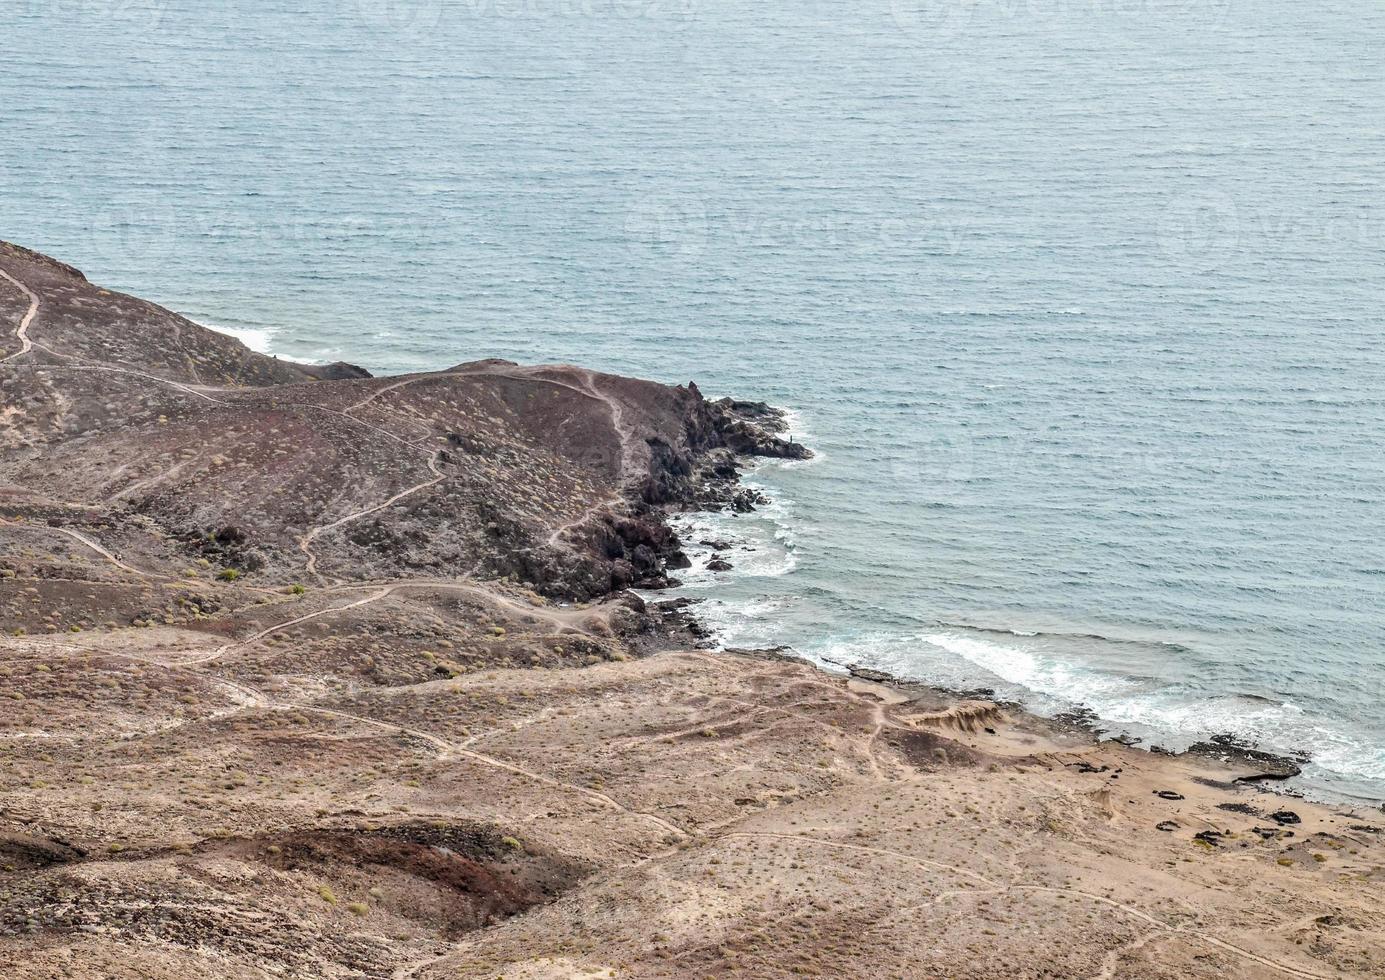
[0,240,796,598]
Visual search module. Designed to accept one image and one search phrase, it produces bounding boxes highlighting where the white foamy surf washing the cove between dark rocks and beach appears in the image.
[650,384,1385,797]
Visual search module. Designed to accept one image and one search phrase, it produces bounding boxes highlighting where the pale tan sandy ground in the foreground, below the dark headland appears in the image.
[0,617,1385,979]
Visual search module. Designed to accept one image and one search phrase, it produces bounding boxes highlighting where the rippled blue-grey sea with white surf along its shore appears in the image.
[0,0,1385,800]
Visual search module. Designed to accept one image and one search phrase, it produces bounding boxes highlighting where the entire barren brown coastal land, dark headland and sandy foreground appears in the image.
[0,245,1385,980]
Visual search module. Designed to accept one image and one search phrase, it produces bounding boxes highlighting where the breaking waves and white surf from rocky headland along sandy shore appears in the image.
[656,393,1385,796]
